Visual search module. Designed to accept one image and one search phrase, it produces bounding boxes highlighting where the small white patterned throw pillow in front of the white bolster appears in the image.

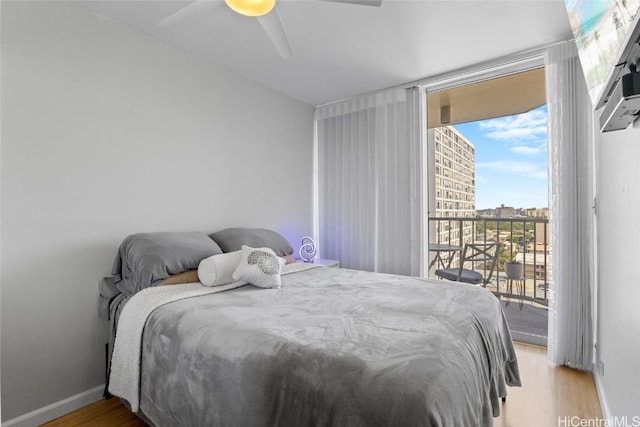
[233,245,284,288]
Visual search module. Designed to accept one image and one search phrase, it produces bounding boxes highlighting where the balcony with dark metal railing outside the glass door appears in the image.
[429,217,550,345]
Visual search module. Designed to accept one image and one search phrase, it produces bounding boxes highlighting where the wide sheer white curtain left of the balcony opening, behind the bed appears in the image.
[316,88,421,275]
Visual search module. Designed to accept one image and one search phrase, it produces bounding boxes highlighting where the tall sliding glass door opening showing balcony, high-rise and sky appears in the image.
[425,64,550,345]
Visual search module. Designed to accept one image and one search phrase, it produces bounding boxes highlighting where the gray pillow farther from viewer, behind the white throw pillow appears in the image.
[209,227,293,256]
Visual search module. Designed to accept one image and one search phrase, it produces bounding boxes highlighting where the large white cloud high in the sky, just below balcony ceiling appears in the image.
[479,109,547,142]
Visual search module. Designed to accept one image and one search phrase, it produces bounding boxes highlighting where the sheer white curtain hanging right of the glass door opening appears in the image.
[545,41,594,370]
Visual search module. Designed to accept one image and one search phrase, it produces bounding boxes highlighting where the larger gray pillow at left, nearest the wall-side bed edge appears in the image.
[112,232,222,295]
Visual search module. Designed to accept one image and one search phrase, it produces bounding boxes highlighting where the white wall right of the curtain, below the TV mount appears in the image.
[595,121,640,422]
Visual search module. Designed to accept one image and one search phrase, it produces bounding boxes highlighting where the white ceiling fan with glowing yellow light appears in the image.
[158,0,382,58]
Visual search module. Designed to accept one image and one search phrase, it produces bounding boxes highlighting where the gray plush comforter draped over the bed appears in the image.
[140,268,520,427]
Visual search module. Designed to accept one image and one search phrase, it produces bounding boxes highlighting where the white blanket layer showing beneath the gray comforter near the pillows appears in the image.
[109,263,319,412]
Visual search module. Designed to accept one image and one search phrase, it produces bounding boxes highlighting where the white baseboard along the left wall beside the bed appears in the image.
[2,384,104,427]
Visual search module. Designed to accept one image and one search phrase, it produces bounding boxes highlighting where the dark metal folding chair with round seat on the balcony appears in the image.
[435,242,500,288]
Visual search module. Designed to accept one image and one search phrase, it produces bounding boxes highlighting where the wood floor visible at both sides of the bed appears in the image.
[44,343,602,427]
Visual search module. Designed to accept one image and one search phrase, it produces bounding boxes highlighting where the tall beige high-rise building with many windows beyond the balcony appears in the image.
[434,126,476,244]
